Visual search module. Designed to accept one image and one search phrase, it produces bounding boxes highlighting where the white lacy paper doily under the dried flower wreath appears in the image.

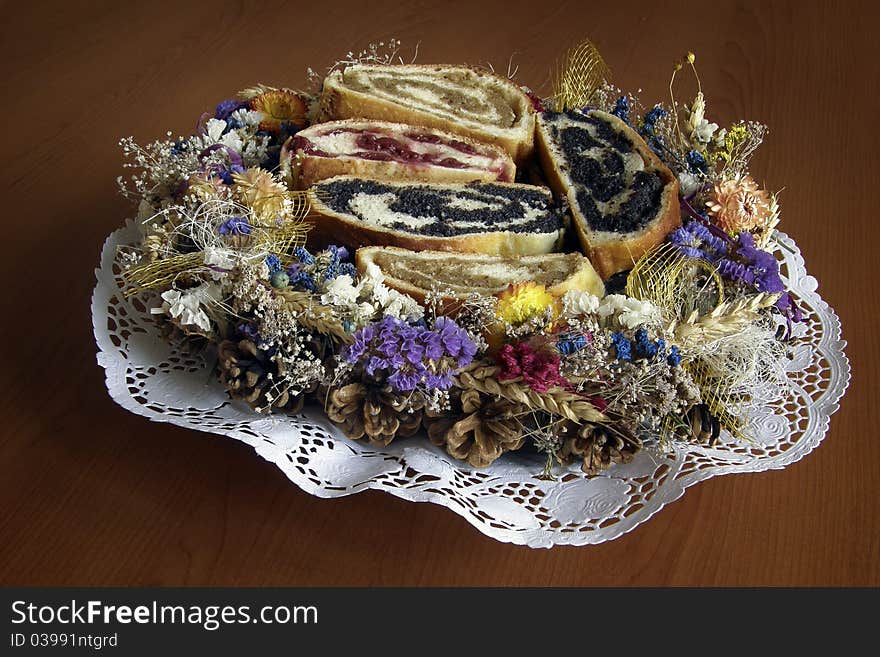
[92,223,850,547]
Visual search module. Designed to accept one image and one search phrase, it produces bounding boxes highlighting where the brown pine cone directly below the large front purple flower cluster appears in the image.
[327,382,423,447]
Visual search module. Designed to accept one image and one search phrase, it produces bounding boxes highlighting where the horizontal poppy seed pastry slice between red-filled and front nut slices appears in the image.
[312,176,564,255]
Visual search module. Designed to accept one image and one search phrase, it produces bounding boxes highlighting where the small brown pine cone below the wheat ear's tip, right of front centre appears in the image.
[556,422,642,475]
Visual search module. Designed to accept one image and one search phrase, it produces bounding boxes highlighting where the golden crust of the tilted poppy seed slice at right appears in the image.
[536,110,681,280]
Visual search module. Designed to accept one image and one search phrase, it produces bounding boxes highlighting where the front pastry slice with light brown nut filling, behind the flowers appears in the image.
[355,246,605,303]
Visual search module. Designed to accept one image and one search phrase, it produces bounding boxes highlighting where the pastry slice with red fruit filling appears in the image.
[281,120,516,189]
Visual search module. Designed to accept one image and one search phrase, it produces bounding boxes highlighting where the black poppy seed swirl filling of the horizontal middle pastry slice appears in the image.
[318,179,563,237]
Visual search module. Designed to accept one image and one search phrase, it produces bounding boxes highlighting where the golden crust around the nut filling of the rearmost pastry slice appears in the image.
[318,64,535,164]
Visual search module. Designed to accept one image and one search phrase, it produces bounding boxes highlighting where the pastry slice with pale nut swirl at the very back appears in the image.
[320,64,535,163]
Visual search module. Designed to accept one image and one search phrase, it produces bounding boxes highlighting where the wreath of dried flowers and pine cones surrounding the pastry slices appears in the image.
[118,40,802,477]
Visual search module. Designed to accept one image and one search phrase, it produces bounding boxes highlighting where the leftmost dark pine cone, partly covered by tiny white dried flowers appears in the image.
[217,340,305,413]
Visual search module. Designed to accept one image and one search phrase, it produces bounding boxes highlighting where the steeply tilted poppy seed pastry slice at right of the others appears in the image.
[537,110,681,279]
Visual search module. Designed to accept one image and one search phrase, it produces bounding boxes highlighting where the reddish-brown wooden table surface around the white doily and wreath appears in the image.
[0,0,880,586]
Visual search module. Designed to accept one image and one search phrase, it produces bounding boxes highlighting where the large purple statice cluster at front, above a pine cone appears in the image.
[342,316,477,392]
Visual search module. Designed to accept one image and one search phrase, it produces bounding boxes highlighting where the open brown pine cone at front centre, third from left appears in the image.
[425,389,526,468]
